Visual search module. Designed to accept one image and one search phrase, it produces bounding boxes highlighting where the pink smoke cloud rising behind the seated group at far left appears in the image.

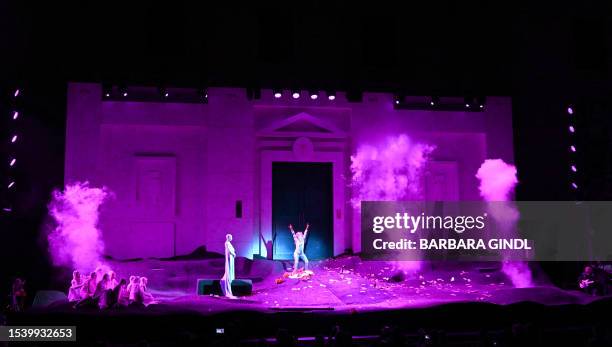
[47,182,110,272]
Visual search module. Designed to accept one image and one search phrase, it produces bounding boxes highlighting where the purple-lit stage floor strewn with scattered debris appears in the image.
[8,256,612,341]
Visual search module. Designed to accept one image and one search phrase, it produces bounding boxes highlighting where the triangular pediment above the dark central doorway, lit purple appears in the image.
[258,112,346,138]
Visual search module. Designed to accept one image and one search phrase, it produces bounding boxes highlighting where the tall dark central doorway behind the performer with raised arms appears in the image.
[272,163,334,259]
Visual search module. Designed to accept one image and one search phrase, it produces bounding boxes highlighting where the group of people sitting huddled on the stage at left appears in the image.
[68,267,155,309]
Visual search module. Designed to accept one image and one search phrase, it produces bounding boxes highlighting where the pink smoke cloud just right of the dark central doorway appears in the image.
[351,134,435,208]
